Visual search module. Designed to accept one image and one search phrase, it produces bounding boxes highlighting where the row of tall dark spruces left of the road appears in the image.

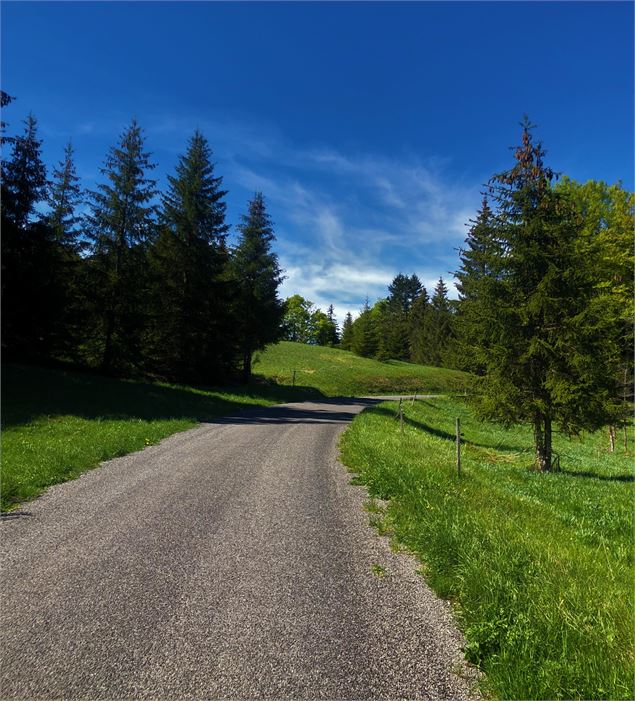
[1,93,284,383]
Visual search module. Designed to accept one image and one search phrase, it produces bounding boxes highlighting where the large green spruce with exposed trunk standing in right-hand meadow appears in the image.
[458,121,628,471]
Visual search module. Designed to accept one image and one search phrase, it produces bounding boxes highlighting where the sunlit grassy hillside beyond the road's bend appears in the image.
[253,341,468,396]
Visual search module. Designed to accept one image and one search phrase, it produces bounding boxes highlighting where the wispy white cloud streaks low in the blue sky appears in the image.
[60,110,480,322]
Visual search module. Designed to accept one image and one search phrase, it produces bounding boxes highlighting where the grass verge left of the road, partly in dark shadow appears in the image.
[0,365,320,510]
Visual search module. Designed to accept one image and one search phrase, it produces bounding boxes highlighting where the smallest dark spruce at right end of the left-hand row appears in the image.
[232,192,284,382]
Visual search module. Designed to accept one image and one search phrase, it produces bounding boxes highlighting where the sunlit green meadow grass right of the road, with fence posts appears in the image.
[341,399,634,699]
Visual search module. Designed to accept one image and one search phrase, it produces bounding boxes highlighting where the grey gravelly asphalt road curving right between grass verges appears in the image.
[0,399,474,699]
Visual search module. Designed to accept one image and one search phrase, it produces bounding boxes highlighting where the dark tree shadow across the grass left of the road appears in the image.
[2,365,323,428]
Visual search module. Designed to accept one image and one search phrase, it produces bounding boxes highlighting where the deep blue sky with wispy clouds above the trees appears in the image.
[1,0,633,319]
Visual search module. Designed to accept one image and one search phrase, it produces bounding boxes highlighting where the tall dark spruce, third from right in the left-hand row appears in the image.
[86,120,156,372]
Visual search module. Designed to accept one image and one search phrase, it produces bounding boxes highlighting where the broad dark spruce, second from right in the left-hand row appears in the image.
[149,131,231,382]
